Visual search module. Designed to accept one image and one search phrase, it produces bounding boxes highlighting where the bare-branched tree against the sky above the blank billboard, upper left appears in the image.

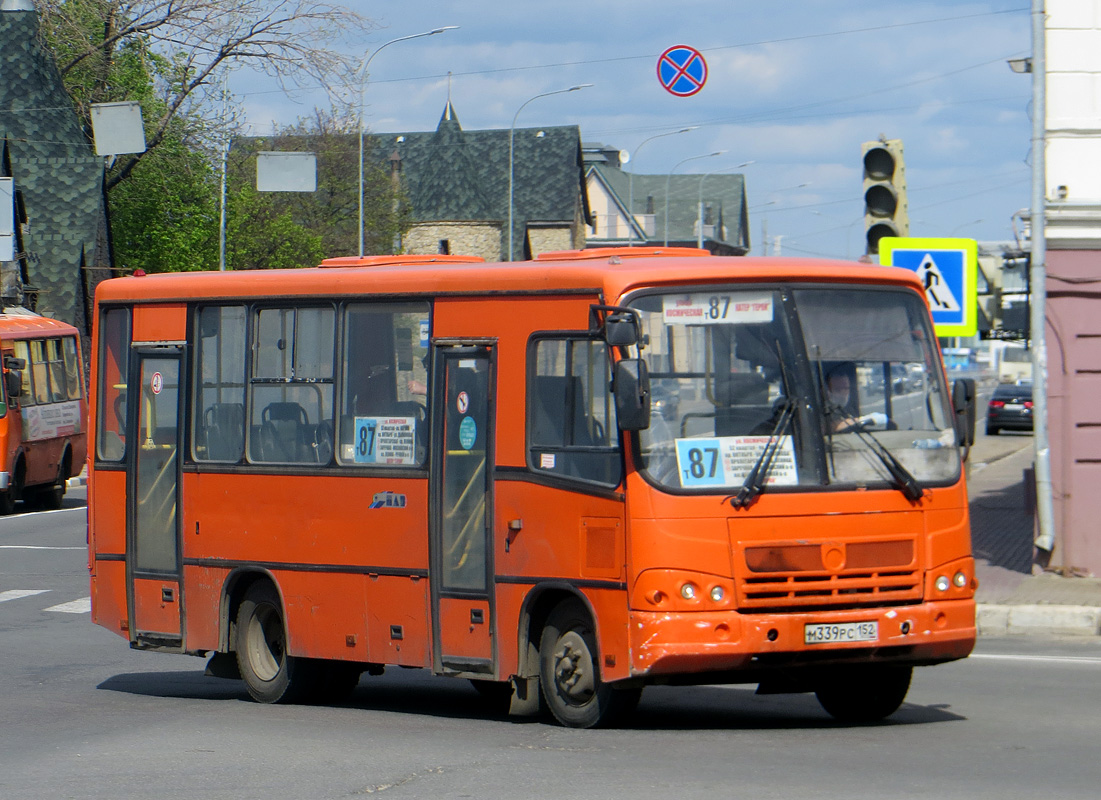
[39,0,371,188]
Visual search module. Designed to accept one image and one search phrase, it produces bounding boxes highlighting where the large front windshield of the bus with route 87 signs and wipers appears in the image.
[630,286,960,495]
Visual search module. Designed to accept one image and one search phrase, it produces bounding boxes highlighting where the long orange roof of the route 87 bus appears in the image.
[96,253,922,303]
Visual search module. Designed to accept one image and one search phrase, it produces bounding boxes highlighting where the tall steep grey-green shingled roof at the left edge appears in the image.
[0,11,109,330]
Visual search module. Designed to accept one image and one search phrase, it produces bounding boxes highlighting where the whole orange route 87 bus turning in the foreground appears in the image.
[88,248,977,727]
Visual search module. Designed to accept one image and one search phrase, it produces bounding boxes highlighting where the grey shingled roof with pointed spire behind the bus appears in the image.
[373,101,591,259]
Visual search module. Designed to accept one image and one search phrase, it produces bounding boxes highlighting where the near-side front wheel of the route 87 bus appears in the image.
[539,600,642,727]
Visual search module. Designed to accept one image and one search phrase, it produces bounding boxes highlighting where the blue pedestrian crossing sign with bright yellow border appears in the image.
[880,237,979,337]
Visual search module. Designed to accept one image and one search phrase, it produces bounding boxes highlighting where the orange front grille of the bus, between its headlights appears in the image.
[737,539,923,609]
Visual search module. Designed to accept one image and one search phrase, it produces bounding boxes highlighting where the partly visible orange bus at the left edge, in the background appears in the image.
[0,308,87,514]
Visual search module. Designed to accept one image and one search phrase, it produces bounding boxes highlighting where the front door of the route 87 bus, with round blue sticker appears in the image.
[429,344,495,676]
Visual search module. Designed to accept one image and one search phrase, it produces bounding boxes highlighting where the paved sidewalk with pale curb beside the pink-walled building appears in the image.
[968,438,1101,636]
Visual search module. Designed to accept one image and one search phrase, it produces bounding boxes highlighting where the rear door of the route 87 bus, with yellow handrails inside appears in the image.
[127,348,183,649]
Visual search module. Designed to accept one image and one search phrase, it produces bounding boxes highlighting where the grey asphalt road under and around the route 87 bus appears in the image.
[0,468,1101,800]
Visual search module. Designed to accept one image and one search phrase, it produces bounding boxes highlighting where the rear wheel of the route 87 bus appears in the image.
[236,581,312,703]
